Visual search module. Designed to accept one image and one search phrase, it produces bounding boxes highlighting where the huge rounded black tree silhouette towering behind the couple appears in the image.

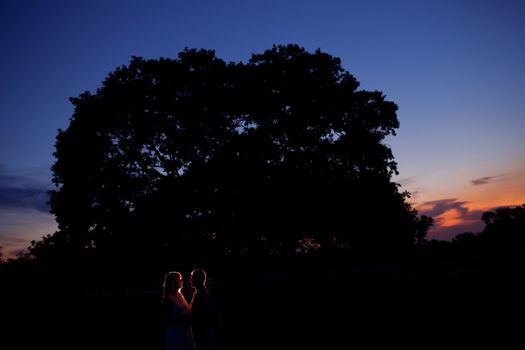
[33,45,428,266]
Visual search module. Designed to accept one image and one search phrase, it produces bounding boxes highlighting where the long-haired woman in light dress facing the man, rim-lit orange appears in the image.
[161,271,195,350]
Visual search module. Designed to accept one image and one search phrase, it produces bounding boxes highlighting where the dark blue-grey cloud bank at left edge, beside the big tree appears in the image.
[0,165,50,213]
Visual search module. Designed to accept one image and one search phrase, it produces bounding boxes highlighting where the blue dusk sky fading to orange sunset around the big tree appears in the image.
[0,0,525,255]
